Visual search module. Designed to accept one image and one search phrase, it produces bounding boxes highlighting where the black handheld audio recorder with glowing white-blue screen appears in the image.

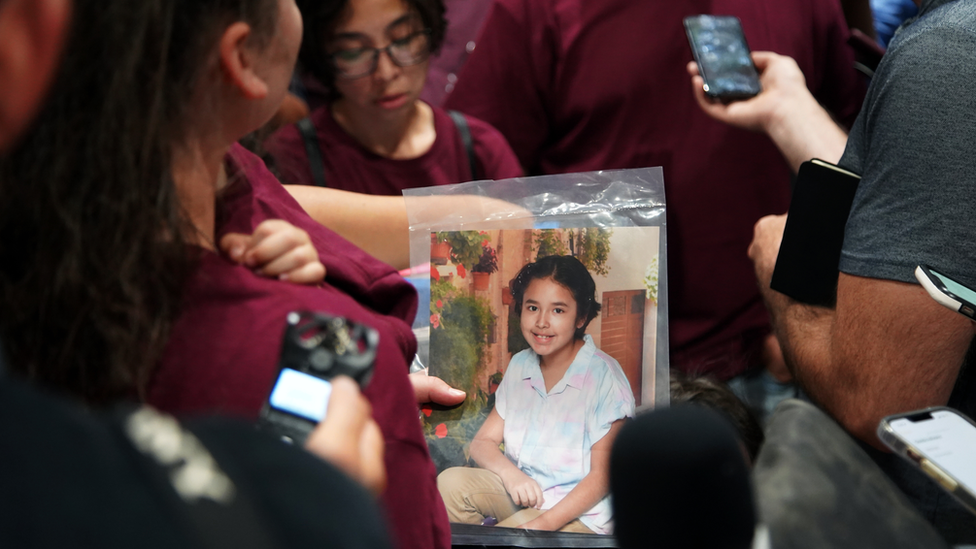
[258,311,379,444]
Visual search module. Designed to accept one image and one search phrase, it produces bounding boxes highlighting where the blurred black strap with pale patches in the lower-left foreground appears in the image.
[115,406,278,549]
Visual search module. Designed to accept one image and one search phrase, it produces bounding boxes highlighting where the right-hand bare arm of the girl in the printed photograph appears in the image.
[522,419,624,531]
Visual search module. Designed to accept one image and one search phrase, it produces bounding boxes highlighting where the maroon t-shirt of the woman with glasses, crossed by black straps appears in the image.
[264,103,522,195]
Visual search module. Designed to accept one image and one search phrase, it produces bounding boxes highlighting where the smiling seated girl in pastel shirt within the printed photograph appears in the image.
[437,256,634,534]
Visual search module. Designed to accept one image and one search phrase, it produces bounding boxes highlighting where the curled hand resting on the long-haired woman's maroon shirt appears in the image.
[220,219,325,284]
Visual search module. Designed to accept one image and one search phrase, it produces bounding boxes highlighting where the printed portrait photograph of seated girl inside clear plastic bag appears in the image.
[423,227,660,534]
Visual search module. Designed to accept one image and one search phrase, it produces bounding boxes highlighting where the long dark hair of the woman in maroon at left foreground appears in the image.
[0,0,278,403]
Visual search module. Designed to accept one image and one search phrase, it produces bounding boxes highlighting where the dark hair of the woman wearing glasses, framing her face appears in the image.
[296,0,447,100]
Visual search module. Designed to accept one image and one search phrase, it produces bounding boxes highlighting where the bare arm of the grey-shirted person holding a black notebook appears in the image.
[749,212,973,449]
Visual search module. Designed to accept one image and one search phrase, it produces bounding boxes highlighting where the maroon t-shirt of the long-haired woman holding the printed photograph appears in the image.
[148,145,451,549]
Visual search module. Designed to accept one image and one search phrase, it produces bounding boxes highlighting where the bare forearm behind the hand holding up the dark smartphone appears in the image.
[766,94,847,173]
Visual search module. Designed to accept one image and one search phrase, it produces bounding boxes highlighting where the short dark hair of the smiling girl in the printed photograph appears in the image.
[508,255,601,339]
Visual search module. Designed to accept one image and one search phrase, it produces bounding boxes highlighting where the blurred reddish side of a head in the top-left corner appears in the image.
[0,0,71,149]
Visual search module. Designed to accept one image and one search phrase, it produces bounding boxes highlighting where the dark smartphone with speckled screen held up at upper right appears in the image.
[684,15,762,101]
